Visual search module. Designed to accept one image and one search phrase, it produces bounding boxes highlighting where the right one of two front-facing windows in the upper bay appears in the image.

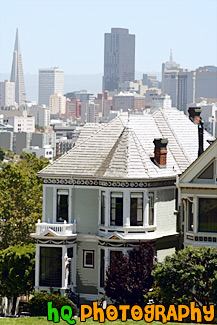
[130,193,143,226]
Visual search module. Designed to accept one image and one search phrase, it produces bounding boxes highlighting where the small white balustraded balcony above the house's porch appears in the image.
[34,220,76,237]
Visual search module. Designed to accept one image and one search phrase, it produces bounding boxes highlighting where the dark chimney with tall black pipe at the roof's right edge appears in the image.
[188,107,204,157]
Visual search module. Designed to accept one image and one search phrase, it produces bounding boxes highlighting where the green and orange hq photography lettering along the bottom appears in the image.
[47,301,215,325]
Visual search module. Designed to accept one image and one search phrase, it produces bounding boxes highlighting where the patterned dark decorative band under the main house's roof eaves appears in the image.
[43,178,176,188]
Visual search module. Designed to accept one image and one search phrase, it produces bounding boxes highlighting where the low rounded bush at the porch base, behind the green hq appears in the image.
[29,292,76,316]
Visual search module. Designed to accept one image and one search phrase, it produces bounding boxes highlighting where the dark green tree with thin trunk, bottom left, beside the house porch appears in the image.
[0,244,35,313]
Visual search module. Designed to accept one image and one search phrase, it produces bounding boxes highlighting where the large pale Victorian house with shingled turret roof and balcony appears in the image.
[32,108,212,300]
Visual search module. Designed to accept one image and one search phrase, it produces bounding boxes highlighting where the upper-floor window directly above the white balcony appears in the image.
[57,189,69,222]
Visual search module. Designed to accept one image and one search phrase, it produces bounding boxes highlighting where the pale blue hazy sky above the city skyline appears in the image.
[0,0,217,74]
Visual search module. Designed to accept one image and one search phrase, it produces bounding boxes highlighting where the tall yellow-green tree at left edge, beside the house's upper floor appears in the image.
[0,154,48,249]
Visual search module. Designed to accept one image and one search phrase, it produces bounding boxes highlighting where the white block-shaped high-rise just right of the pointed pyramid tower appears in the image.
[38,67,64,106]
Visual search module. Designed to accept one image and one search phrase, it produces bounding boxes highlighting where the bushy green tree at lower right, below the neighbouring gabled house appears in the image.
[146,247,217,306]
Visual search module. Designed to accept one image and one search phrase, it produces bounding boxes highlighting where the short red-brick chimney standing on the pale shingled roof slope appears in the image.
[153,138,168,168]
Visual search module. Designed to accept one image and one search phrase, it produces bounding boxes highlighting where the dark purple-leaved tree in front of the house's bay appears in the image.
[105,243,153,306]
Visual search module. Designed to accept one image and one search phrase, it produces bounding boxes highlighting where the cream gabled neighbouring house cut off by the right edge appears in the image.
[177,140,217,248]
